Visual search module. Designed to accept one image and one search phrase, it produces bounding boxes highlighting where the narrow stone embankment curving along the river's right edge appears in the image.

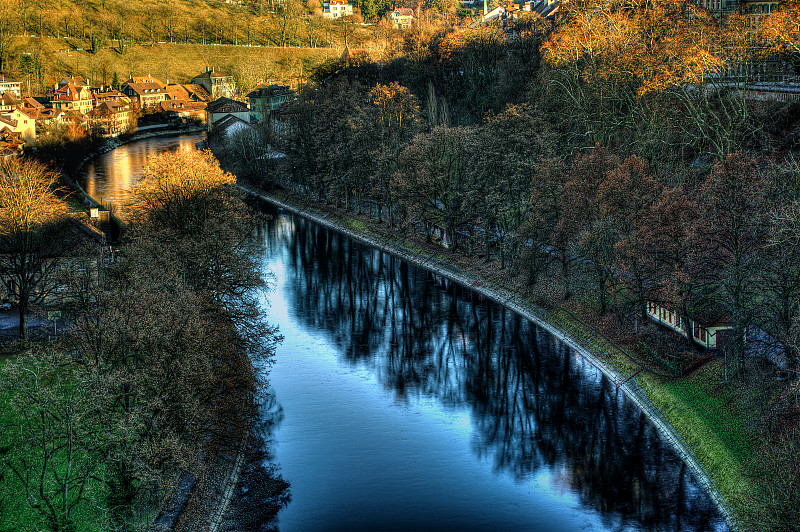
[239,183,737,530]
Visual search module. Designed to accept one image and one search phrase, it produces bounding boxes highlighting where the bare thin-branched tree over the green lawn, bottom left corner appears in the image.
[0,347,103,532]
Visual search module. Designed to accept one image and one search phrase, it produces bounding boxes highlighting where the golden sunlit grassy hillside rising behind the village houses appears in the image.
[0,0,400,92]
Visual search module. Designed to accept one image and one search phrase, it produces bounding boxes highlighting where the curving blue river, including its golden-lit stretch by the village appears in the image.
[87,139,727,532]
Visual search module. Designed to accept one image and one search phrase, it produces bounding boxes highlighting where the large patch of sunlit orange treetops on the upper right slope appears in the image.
[542,0,748,95]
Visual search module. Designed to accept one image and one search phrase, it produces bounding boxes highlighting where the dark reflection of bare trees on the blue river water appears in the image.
[269,213,718,530]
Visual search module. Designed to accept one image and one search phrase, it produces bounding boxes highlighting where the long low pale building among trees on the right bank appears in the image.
[647,301,732,349]
